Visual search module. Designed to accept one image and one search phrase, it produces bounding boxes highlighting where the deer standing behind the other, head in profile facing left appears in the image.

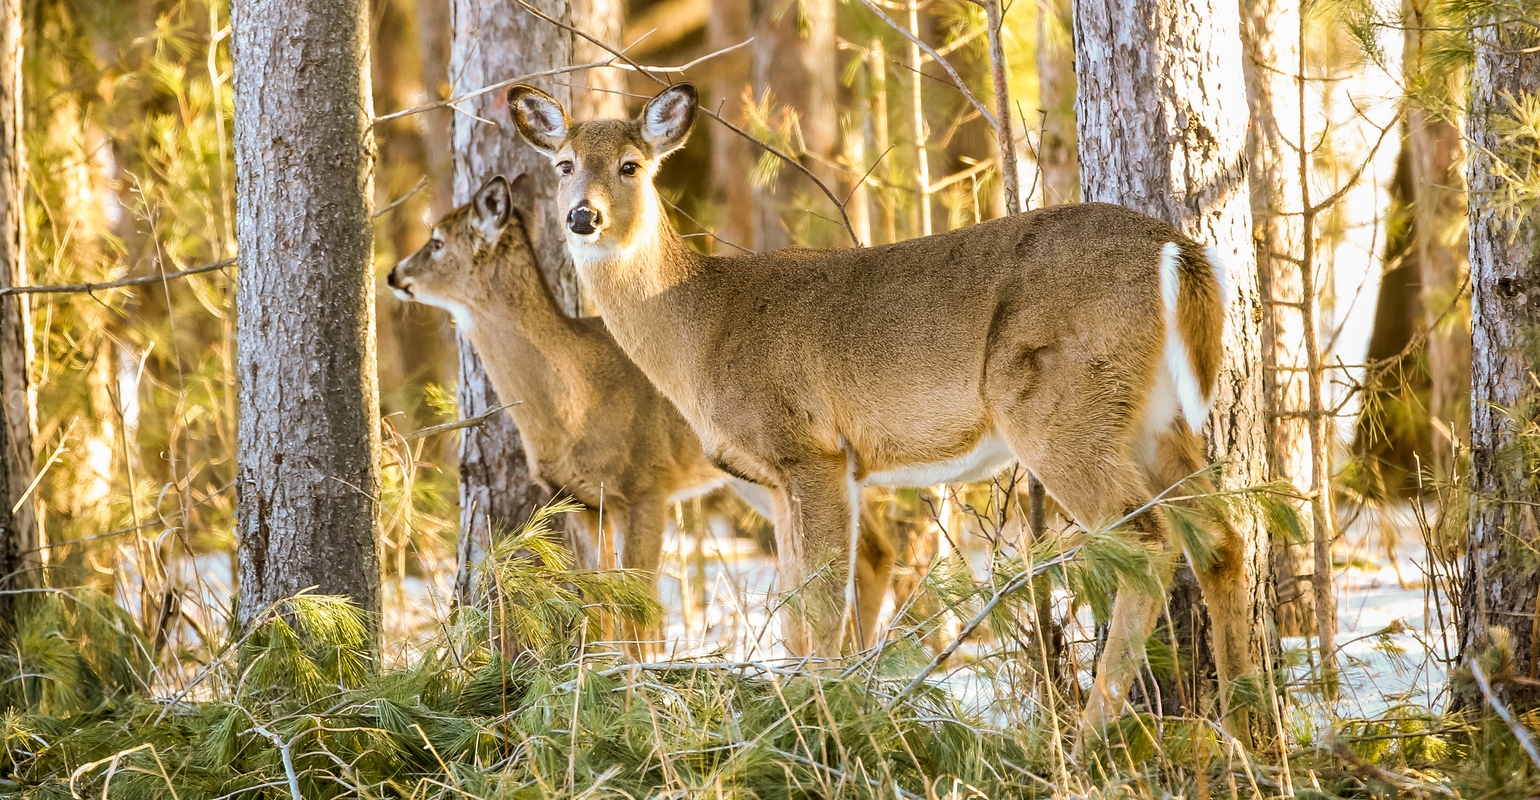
[387,174,893,641]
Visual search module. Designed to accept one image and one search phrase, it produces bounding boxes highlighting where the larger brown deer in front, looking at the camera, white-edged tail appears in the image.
[507,83,1254,741]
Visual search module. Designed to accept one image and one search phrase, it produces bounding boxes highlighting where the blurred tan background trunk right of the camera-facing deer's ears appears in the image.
[745,0,842,253]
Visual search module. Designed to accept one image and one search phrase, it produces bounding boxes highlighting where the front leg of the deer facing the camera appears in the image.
[775,453,858,658]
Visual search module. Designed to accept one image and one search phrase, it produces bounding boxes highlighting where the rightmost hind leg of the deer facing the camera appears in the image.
[1147,419,1255,743]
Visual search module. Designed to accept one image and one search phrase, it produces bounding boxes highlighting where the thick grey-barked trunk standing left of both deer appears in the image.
[233,0,380,623]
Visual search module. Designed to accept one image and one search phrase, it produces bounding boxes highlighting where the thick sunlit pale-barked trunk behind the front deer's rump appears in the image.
[1075,0,1271,714]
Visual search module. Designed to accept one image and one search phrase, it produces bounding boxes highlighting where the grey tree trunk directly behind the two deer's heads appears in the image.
[450,0,587,597]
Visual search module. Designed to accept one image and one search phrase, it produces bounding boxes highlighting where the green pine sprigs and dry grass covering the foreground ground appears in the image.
[0,506,1540,800]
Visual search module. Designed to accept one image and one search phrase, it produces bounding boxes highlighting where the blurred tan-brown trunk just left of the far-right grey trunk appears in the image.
[1403,0,1471,476]
